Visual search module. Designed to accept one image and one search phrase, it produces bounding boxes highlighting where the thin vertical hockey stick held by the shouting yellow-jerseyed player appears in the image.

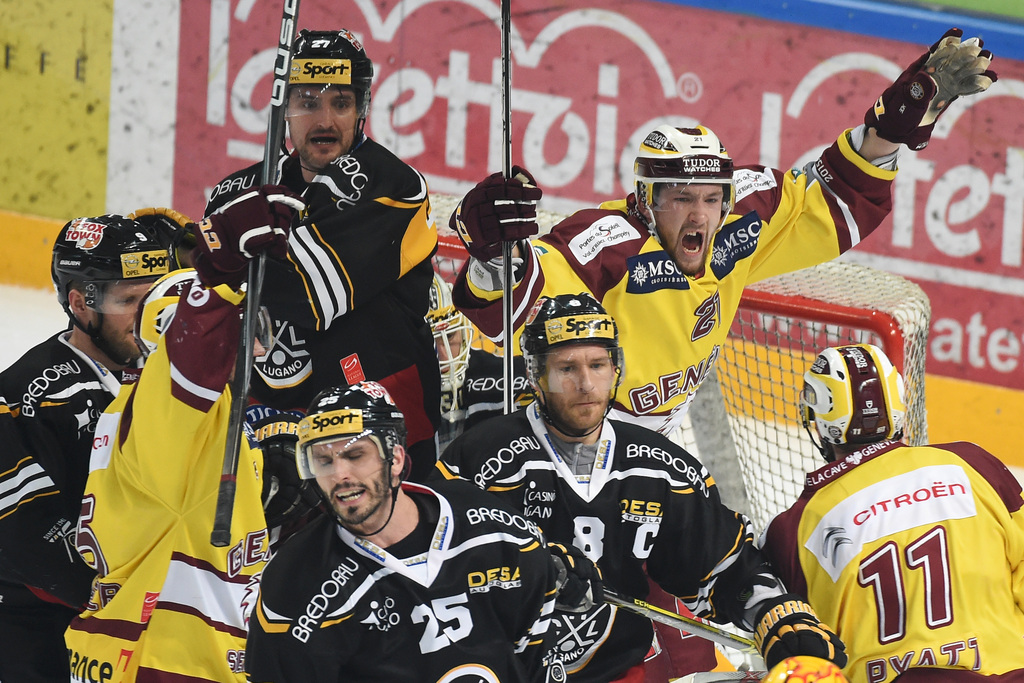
[501,0,515,415]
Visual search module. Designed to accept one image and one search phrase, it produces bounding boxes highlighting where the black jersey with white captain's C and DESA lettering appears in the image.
[437,403,774,682]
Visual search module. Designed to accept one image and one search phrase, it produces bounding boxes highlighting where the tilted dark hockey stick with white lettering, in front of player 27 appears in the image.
[210,0,299,548]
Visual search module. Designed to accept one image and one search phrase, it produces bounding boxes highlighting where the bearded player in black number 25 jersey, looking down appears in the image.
[246,382,564,683]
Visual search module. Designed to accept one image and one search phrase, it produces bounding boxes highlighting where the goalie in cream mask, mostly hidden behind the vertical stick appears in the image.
[427,272,532,453]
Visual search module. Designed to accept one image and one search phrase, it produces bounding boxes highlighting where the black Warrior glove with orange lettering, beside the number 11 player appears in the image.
[754,593,847,669]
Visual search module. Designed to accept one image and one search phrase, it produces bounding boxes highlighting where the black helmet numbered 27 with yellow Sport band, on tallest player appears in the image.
[288,29,374,129]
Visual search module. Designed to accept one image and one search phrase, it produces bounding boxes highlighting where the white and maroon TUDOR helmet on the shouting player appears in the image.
[633,124,736,233]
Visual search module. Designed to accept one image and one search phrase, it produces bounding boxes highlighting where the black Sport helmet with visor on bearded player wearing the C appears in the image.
[519,293,626,436]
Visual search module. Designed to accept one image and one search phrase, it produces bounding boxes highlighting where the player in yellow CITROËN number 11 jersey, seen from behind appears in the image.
[762,344,1024,683]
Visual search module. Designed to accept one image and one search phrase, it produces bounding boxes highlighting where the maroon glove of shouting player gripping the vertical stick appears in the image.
[449,166,543,261]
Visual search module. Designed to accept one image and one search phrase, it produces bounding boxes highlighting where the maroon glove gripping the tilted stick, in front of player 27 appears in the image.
[193,185,305,289]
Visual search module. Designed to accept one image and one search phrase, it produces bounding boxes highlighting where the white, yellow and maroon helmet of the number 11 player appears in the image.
[800,344,906,462]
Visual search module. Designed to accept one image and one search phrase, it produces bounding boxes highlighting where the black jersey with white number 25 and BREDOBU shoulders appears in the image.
[246,481,556,683]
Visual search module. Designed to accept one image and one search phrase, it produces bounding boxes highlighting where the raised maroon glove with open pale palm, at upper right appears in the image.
[864,29,997,150]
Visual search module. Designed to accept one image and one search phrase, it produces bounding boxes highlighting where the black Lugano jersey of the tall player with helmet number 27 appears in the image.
[206,138,440,458]
